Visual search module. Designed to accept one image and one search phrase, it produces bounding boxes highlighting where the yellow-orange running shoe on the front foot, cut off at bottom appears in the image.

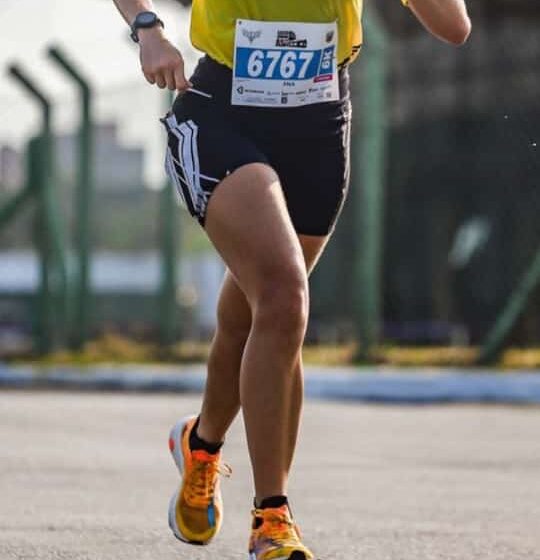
[249,505,314,560]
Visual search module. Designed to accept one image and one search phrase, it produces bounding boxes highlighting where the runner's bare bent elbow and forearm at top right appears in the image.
[408,0,471,45]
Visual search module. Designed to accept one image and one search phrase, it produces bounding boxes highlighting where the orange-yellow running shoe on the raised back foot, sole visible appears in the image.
[169,416,231,544]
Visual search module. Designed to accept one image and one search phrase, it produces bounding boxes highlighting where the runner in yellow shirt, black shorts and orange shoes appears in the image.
[114,0,470,560]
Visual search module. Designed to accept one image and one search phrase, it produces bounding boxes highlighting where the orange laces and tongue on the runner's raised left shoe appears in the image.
[187,450,232,507]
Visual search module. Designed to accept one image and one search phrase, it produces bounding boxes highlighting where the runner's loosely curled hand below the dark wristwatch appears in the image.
[138,26,191,91]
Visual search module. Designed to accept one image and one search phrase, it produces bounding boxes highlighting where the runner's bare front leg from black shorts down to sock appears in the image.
[201,164,308,498]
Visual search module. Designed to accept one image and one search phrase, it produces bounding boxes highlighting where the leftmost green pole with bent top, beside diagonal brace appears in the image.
[8,64,67,353]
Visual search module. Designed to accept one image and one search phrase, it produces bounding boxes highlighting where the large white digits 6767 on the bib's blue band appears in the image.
[247,49,315,80]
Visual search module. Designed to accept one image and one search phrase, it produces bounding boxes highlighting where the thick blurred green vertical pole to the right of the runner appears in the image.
[352,11,387,360]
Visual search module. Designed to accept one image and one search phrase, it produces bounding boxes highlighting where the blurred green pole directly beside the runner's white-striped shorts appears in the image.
[159,92,179,346]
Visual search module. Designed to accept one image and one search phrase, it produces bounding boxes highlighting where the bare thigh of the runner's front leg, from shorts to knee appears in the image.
[205,163,307,301]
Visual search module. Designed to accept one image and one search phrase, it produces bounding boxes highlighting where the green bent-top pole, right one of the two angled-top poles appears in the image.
[47,46,94,349]
